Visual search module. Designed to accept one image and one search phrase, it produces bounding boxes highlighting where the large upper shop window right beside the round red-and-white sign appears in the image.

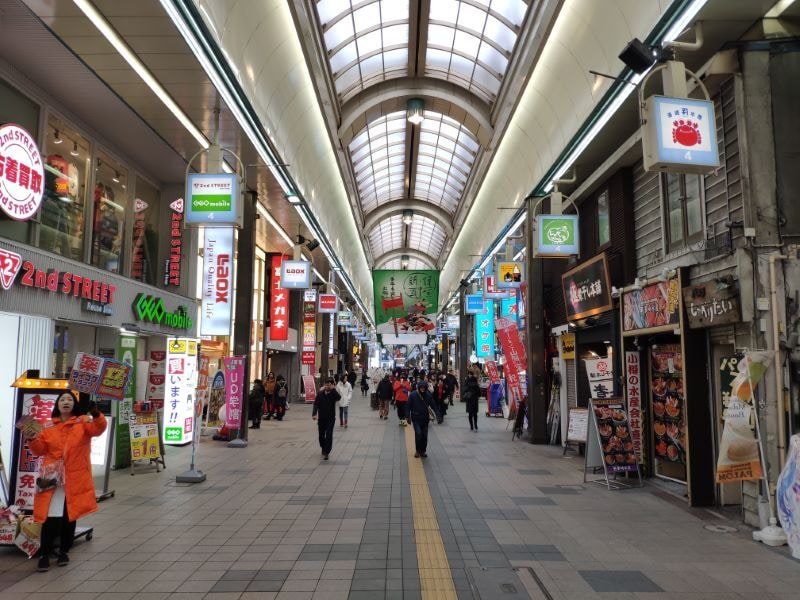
[39,115,91,261]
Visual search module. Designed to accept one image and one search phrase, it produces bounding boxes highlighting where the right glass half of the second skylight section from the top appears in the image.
[414,111,479,213]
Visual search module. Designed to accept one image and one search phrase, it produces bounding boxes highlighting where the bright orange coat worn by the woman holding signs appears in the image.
[28,414,107,523]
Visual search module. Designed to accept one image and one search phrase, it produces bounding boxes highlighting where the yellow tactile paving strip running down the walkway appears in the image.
[406,425,458,600]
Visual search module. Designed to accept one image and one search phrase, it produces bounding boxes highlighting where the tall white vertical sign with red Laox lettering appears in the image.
[200,227,234,335]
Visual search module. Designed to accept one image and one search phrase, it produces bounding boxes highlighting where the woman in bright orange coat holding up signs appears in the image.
[28,392,106,571]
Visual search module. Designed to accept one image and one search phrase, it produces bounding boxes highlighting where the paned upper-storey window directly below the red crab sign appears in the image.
[662,173,703,252]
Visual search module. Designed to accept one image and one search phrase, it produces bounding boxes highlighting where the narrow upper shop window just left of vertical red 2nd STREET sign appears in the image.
[131,177,160,285]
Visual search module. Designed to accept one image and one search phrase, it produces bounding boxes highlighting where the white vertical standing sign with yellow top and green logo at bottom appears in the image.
[163,338,199,445]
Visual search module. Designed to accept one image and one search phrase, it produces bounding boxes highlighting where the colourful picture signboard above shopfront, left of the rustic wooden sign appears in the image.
[622,277,681,334]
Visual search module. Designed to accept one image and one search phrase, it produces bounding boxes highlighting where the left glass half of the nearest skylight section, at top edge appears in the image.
[317,0,410,102]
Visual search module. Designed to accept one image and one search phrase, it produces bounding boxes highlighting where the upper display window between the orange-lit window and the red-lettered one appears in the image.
[91,152,128,273]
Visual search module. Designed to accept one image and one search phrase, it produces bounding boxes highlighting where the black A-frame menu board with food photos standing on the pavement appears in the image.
[591,398,639,473]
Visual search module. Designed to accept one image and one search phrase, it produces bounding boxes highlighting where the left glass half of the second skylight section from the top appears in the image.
[349,111,406,212]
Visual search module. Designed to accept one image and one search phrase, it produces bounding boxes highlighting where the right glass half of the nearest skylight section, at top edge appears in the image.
[425,0,528,103]
